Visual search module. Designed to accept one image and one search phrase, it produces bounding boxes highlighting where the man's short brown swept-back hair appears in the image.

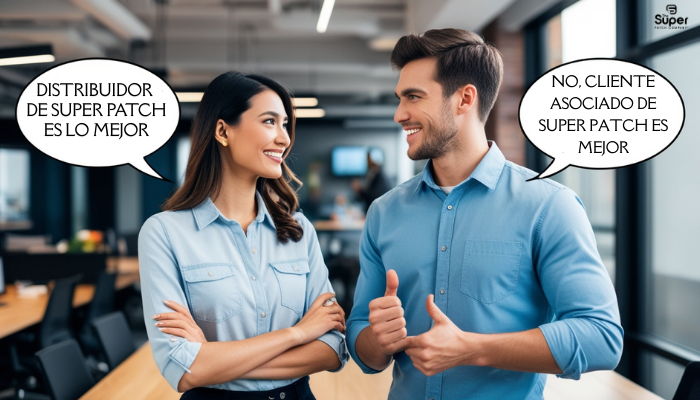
[391,28,503,123]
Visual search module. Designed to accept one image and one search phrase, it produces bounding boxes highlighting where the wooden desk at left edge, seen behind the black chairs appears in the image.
[0,274,139,338]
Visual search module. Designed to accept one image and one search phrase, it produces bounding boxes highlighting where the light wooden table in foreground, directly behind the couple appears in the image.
[81,343,662,400]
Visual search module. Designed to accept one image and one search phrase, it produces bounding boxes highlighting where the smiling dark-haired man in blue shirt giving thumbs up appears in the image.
[347,29,622,400]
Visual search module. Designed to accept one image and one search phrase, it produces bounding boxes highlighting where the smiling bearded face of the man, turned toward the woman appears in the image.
[394,58,457,160]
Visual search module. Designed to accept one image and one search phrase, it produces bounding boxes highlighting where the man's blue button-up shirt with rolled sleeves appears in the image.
[347,142,622,400]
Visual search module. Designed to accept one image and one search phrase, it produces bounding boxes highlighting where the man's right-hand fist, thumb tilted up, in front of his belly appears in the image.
[405,294,478,376]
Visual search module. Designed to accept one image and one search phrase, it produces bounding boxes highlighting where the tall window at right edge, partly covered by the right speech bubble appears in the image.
[644,39,700,398]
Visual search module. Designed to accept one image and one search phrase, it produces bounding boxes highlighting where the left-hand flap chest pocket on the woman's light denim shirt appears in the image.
[182,263,242,323]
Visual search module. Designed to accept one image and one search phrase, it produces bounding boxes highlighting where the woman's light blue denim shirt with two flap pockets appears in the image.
[139,193,348,391]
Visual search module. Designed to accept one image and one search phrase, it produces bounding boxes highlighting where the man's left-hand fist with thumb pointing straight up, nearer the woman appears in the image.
[369,269,406,356]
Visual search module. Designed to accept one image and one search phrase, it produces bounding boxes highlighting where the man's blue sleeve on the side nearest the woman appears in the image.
[347,205,386,374]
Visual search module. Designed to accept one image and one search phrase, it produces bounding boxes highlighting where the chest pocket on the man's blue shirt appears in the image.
[461,240,523,304]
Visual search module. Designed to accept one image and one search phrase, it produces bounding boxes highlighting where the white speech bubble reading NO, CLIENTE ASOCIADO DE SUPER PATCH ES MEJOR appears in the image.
[518,58,685,180]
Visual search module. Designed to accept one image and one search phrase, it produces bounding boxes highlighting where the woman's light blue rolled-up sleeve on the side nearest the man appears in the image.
[303,217,348,372]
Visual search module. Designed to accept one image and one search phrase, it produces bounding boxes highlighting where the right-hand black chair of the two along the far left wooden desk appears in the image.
[80,271,117,353]
